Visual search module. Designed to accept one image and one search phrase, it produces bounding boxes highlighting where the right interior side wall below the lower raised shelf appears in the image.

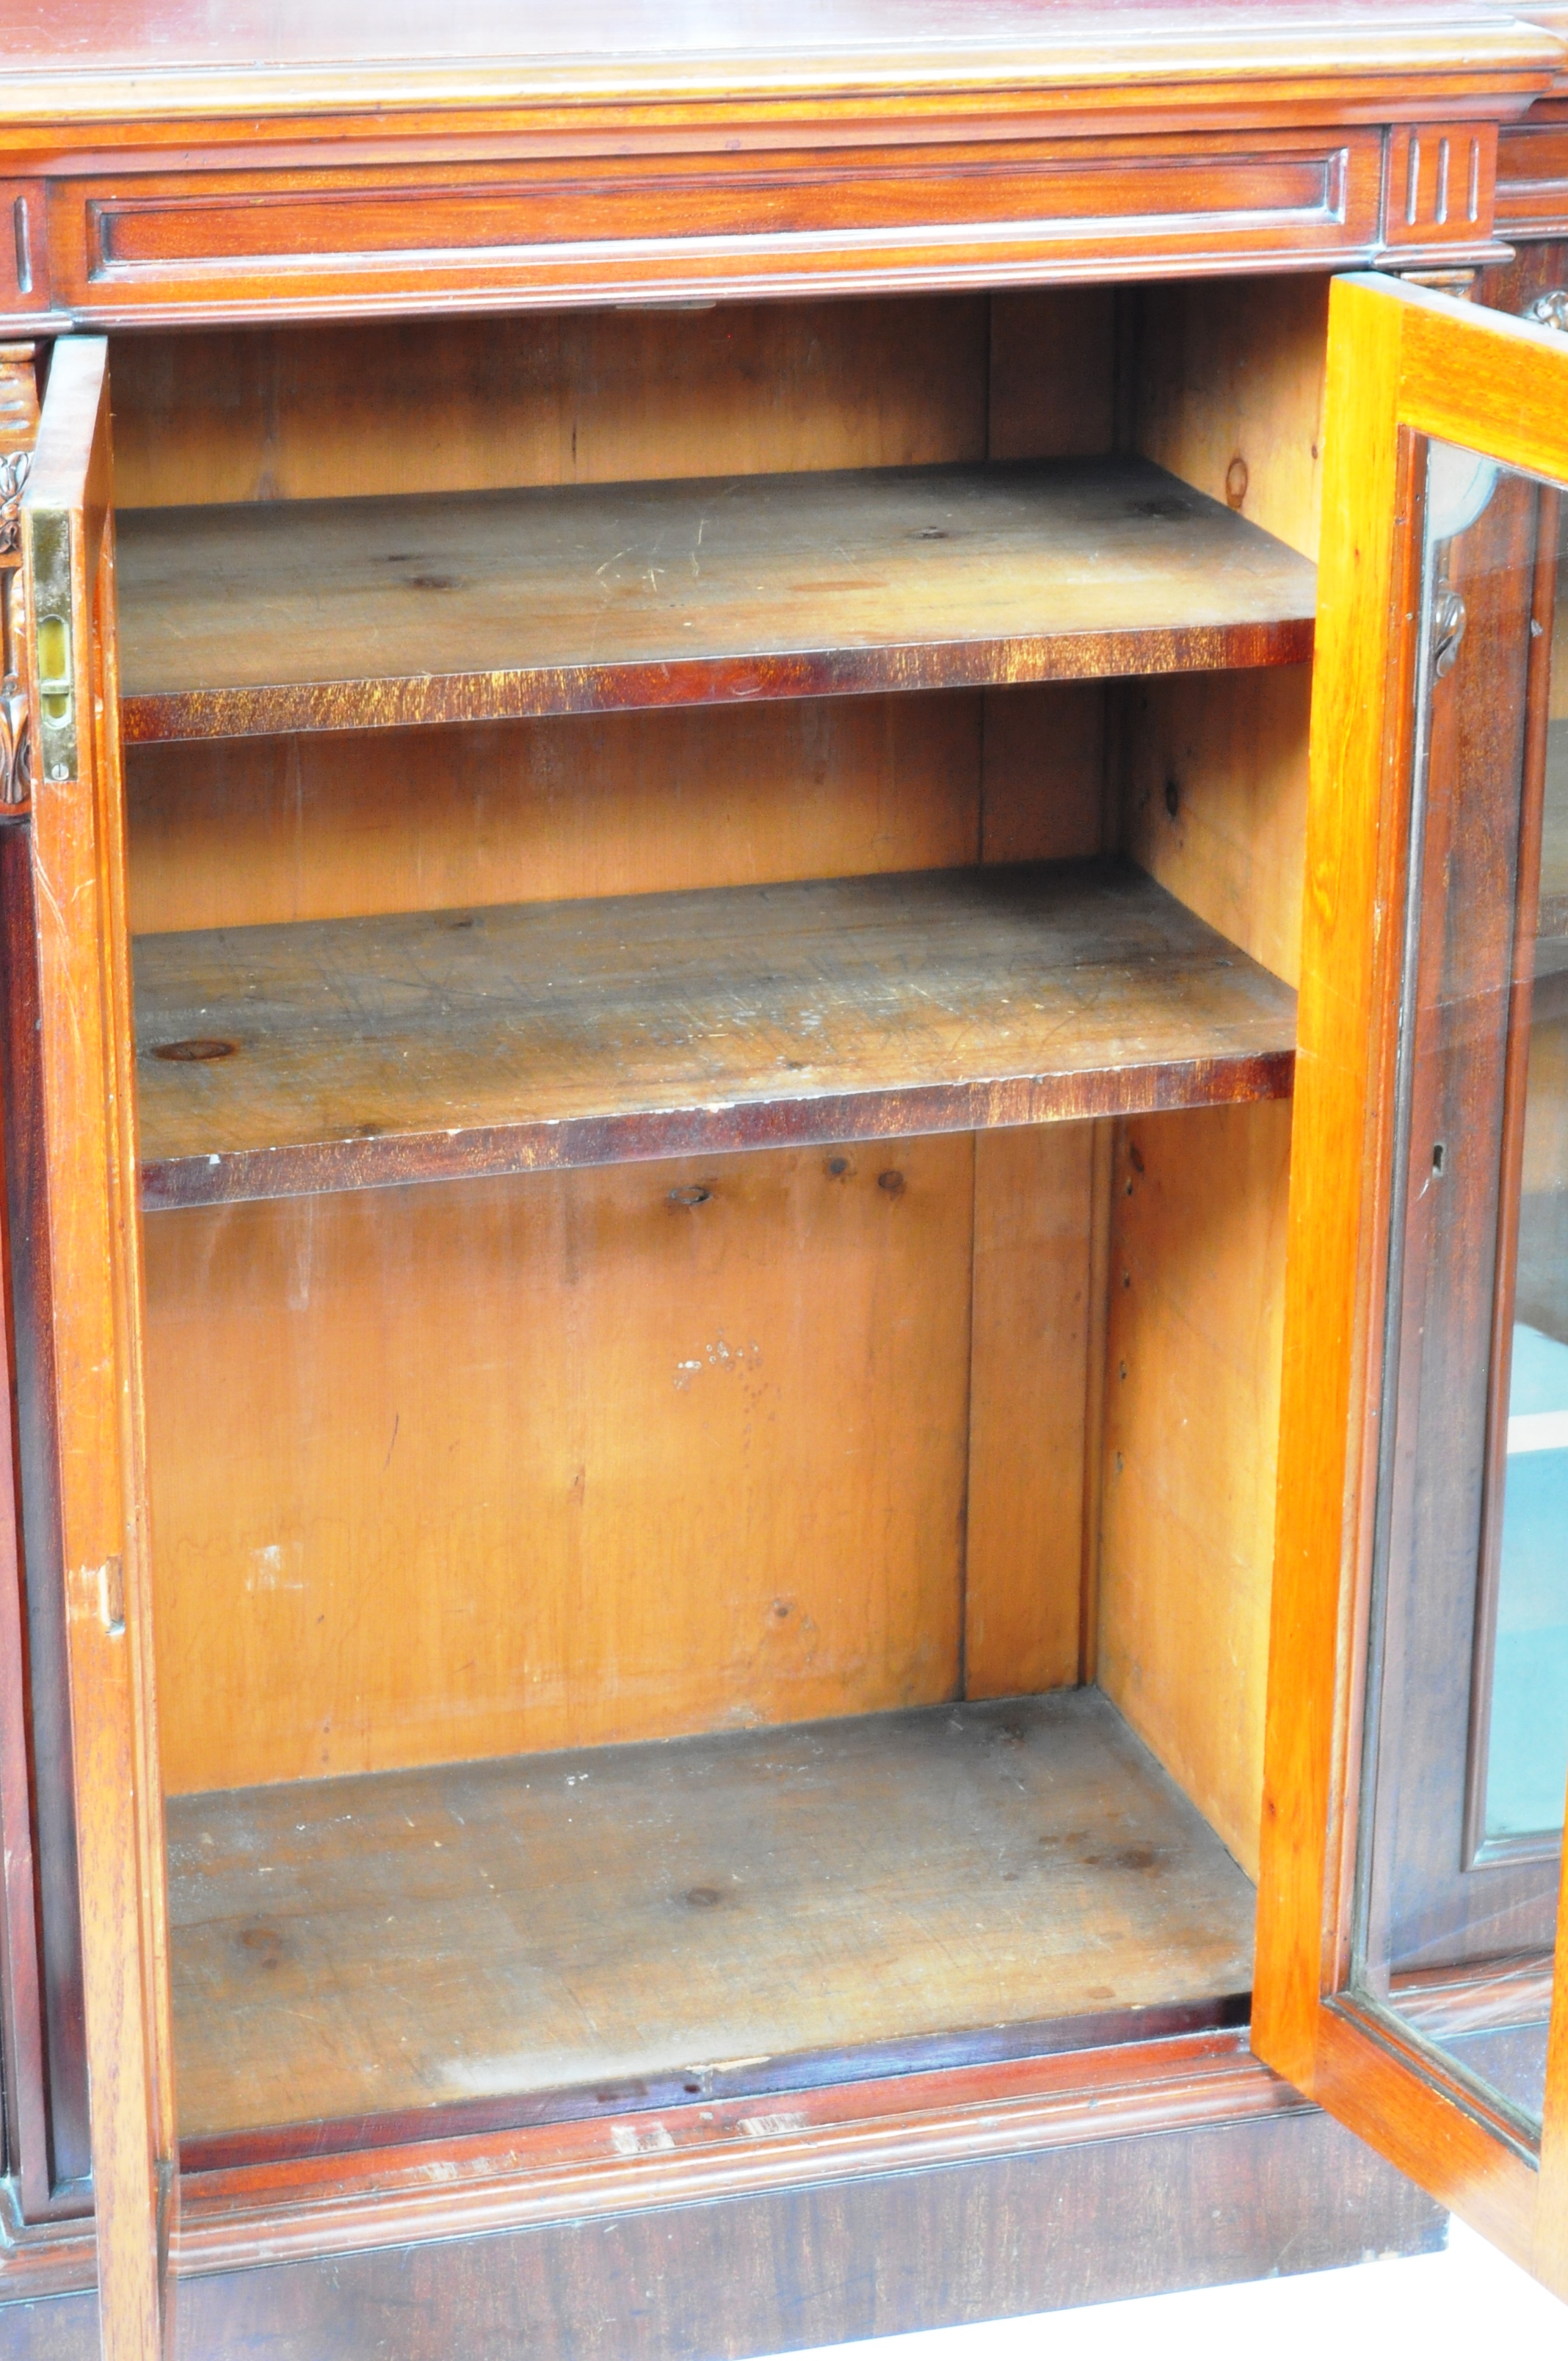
[1098,1100,1289,1877]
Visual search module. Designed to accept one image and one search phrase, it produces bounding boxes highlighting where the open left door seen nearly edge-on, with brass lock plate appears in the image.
[17,338,175,2361]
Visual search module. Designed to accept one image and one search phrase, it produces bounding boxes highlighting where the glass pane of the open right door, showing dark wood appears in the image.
[1353,444,1568,2146]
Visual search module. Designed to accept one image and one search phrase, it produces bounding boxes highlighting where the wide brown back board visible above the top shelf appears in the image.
[113,295,990,507]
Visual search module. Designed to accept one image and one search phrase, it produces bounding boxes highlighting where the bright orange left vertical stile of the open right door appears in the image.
[1254,271,1415,2089]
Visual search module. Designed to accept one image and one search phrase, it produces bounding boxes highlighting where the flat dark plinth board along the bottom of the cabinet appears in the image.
[0,2068,1445,2361]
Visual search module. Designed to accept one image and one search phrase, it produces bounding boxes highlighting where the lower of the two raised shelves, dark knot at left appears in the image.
[134,862,1294,1206]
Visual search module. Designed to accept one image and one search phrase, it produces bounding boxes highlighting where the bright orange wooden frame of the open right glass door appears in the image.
[1252,274,1568,2295]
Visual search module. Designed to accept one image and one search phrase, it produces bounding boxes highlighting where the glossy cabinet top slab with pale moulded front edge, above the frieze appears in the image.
[0,0,1568,156]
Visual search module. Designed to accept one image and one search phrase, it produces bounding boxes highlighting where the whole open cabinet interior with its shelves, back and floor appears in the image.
[111,276,1327,2155]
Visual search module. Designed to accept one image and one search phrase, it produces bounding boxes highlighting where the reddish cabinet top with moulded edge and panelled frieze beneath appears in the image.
[0,0,1568,336]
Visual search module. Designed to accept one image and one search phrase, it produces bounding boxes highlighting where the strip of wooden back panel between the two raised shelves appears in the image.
[128,682,1103,935]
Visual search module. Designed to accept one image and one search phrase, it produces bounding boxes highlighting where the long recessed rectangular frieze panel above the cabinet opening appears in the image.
[52,125,1388,324]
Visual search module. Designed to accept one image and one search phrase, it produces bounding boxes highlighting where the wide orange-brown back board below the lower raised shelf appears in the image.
[146,1136,973,1792]
